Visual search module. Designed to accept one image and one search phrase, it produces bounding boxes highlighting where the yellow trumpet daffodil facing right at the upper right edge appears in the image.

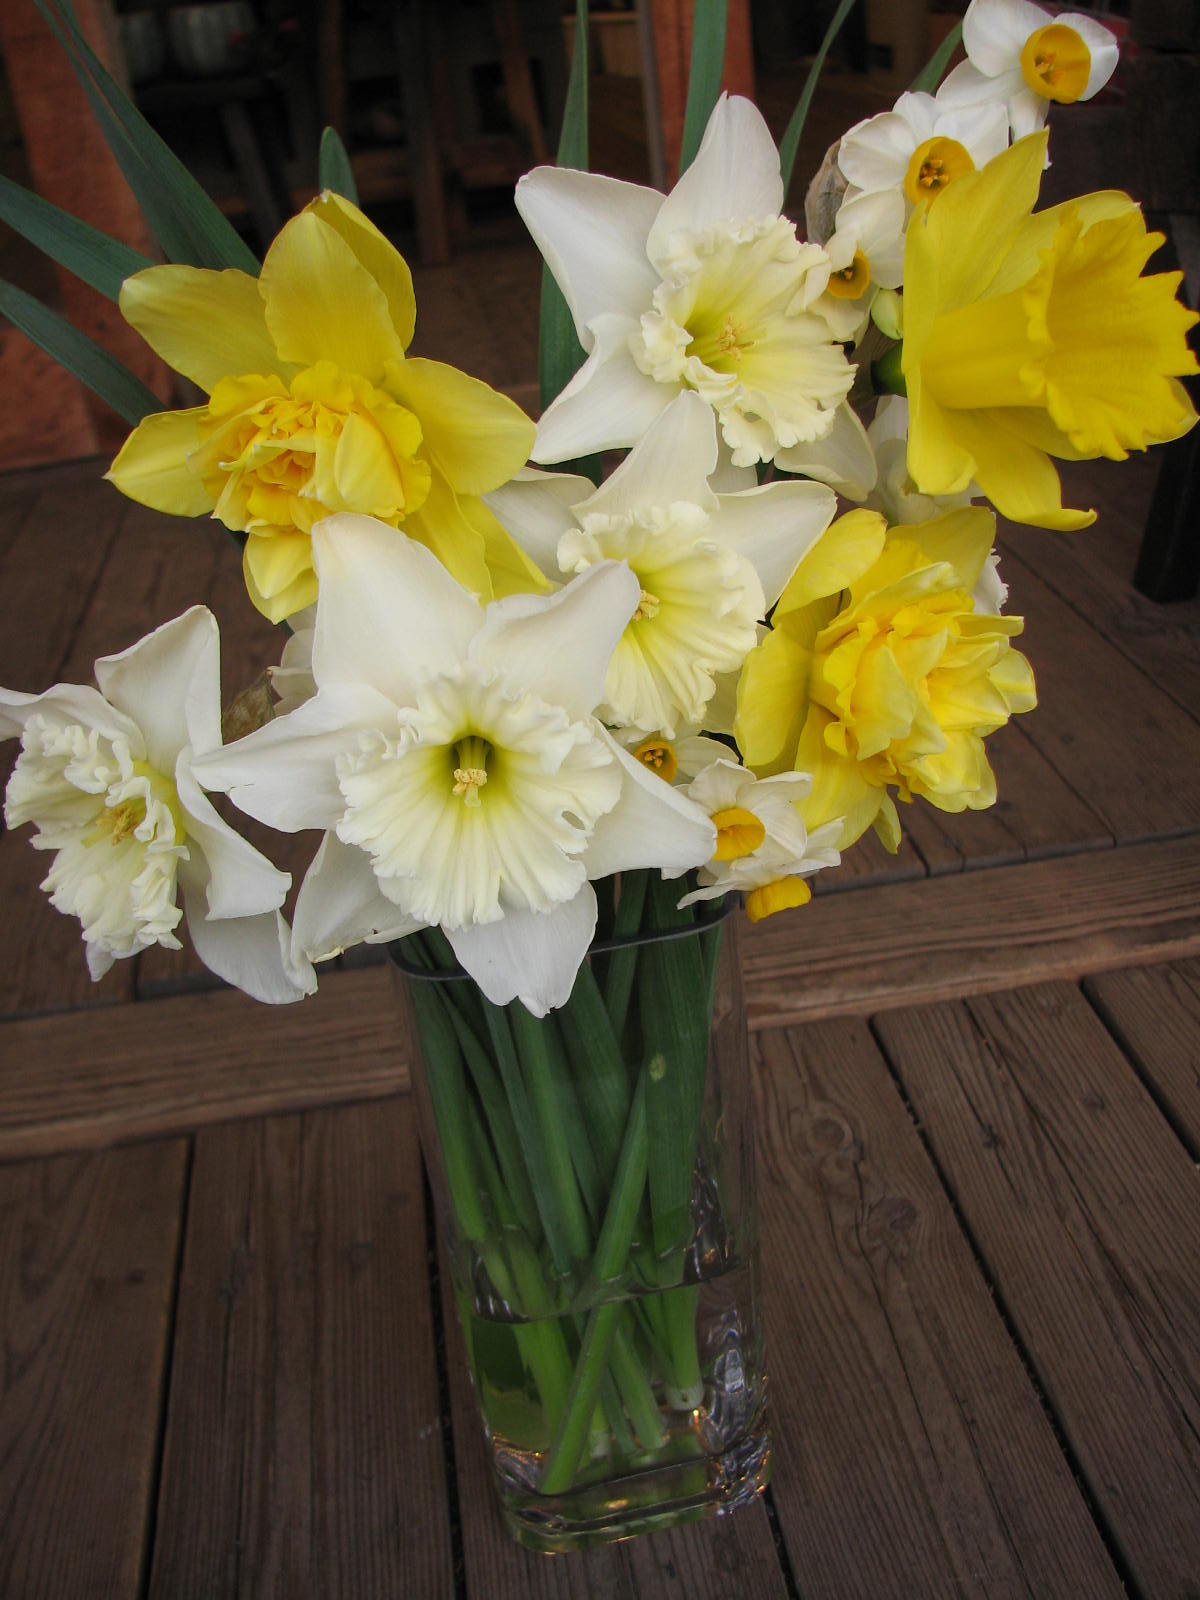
[902,133,1197,528]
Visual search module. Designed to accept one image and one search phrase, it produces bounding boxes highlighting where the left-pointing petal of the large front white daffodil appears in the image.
[192,685,395,834]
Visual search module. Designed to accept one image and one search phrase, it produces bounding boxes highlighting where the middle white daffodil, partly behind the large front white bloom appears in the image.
[488,394,837,739]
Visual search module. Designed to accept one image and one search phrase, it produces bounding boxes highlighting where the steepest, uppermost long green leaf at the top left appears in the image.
[34,0,259,274]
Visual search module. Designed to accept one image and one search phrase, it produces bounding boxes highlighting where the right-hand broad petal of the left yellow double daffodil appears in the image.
[386,357,538,494]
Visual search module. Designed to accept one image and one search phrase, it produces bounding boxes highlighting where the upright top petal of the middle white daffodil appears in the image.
[576,392,717,518]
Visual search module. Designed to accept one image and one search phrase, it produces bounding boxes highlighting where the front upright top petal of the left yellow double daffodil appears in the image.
[259,211,403,382]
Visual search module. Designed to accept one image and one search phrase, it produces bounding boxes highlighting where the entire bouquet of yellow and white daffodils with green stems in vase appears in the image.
[0,0,1197,1548]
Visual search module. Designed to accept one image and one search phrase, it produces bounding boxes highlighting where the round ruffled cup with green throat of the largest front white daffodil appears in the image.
[338,669,621,930]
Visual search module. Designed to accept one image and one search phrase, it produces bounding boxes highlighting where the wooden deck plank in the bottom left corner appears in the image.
[0,1141,187,1600]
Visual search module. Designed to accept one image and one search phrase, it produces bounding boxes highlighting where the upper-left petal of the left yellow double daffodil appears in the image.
[120,267,288,394]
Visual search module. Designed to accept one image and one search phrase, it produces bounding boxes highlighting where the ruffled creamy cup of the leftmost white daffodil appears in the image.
[5,715,189,978]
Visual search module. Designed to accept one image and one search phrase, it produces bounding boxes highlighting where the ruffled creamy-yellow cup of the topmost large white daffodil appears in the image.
[630,216,854,466]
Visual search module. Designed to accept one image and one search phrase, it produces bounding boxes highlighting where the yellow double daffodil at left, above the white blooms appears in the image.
[109,192,541,622]
